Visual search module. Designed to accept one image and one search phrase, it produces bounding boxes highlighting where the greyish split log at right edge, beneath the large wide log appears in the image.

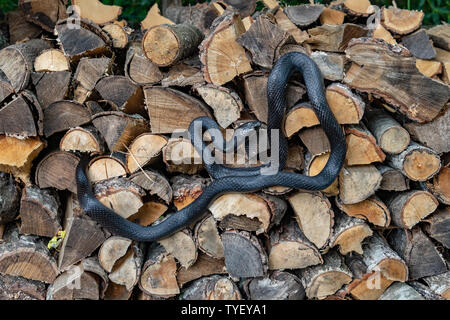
[405,108,450,153]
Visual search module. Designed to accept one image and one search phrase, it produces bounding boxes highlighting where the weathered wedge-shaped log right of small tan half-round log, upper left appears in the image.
[72,57,112,103]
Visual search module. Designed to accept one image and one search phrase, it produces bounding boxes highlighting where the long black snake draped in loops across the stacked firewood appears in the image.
[76,52,346,241]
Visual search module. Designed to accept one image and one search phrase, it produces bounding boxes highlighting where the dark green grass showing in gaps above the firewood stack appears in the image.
[0,0,450,25]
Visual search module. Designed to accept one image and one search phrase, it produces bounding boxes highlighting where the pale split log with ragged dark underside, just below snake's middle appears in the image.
[208,193,272,234]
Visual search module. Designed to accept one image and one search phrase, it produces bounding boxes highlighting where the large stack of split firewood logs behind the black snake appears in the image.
[0,0,450,300]
